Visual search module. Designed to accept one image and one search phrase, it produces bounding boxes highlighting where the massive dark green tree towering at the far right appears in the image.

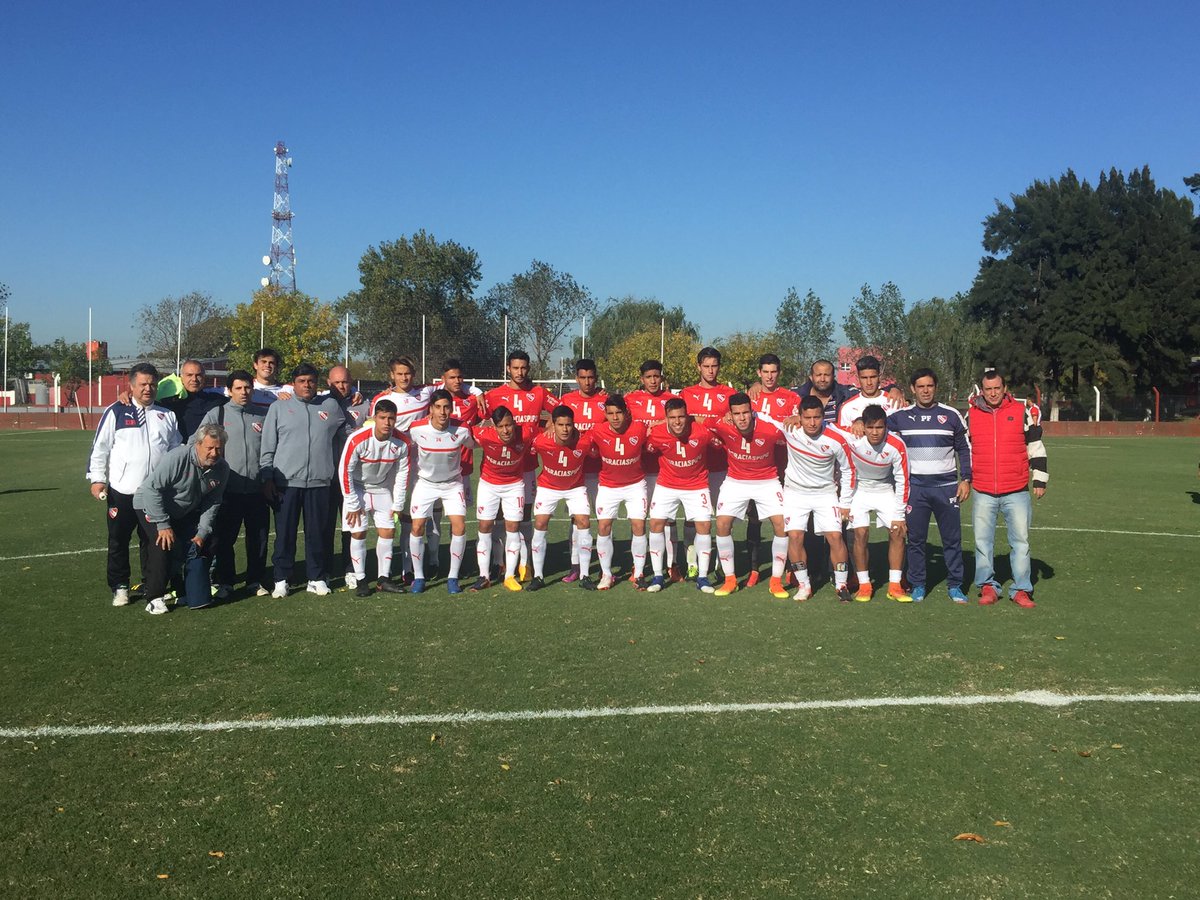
[970,167,1200,396]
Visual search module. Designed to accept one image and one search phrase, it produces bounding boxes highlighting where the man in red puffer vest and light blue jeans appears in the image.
[967,368,1050,610]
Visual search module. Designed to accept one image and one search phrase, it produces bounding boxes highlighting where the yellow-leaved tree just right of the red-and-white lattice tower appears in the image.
[229,284,342,379]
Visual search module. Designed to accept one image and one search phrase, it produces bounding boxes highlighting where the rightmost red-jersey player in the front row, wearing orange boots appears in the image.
[713,394,787,599]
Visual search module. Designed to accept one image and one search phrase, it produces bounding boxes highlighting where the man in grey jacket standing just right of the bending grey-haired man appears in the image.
[202,370,271,600]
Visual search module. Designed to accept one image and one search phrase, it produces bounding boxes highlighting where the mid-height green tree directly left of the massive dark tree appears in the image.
[906,294,986,397]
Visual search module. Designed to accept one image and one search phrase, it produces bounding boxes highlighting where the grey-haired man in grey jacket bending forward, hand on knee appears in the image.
[133,425,229,616]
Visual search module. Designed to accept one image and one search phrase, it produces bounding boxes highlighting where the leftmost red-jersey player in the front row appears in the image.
[470,407,533,590]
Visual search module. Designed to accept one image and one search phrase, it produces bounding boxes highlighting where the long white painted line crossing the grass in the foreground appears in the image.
[0,691,1200,740]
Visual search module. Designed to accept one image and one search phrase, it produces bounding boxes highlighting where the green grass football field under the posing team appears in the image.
[0,433,1200,898]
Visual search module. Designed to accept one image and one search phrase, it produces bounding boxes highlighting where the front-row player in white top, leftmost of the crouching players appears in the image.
[337,400,408,596]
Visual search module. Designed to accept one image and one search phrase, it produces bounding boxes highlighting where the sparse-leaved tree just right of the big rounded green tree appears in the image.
[485,259,596,374]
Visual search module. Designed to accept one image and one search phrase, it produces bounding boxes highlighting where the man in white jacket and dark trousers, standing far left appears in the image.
[86,362,181,606]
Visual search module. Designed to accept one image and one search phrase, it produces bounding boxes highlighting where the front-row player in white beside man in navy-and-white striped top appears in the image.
[848,403,912,604]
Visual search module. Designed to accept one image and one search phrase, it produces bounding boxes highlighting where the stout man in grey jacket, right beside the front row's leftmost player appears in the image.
[259,362,346,598]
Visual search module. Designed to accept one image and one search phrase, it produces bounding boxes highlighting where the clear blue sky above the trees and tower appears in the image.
[0,1,1200,354]
